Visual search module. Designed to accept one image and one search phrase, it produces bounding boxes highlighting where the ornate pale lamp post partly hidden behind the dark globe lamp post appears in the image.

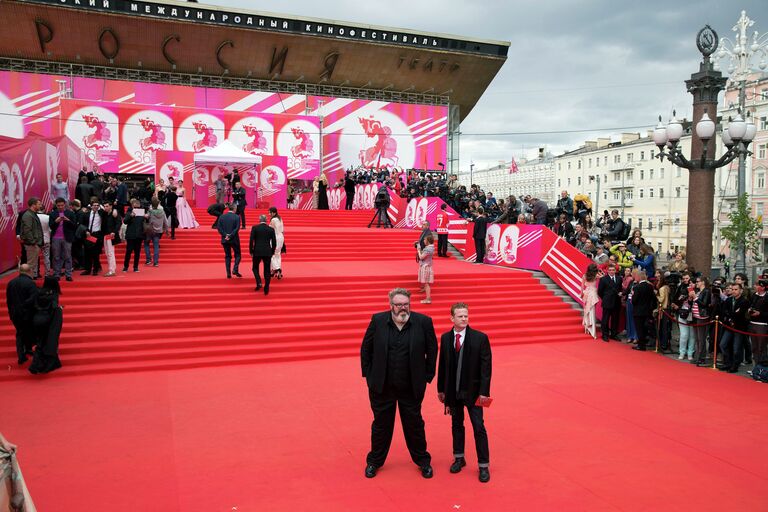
[714,11,768,272]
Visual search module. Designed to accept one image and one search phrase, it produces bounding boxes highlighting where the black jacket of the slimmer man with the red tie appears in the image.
[437,326,492,406]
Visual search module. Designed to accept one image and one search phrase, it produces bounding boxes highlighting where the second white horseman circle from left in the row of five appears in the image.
[123,110,173,164]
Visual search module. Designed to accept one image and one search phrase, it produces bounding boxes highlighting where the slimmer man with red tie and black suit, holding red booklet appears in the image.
[437,302,491,483]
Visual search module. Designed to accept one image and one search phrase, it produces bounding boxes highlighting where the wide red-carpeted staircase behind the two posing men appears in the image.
[0,206,586,380]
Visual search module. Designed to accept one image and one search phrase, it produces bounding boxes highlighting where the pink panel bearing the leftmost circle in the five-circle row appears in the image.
[61,100,120,173]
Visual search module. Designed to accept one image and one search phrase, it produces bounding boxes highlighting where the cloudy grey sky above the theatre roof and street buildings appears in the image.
[206,0,768,169]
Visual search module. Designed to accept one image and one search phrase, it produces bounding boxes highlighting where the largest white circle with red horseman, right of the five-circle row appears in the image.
[339,110,421,169]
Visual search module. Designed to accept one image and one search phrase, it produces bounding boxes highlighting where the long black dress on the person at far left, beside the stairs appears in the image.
[29,289,64,373]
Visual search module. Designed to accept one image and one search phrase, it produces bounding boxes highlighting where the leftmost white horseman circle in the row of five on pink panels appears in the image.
[64,107,119,164]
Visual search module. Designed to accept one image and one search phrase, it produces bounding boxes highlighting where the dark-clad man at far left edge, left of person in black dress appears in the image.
[5,263,39,364]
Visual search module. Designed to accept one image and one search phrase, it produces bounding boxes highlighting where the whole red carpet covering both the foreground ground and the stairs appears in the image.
[0,207,768,511]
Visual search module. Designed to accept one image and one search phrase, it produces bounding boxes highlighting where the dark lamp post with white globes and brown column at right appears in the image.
[653,25,754,274]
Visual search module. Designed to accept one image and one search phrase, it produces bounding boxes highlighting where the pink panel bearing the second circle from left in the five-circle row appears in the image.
[118,104,174,174]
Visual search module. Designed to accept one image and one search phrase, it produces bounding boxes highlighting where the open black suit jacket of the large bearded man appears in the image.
[360,311,437,400]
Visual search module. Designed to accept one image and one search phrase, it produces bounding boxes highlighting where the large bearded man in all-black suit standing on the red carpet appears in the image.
[360,288,437,478]
